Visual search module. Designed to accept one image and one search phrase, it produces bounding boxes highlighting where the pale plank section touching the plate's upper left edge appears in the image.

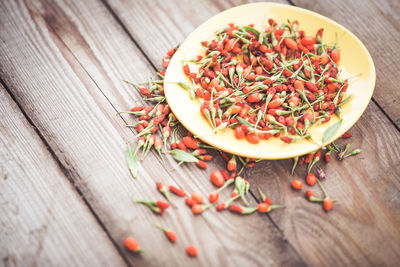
[104,0,288,69]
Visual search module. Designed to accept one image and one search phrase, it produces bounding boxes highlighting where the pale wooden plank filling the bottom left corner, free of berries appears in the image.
[0,85,126,266]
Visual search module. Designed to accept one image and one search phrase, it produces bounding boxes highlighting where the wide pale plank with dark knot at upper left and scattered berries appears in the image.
[0,1,303,266]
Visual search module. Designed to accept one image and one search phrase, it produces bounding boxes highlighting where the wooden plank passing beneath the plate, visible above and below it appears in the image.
[103,1,400,266]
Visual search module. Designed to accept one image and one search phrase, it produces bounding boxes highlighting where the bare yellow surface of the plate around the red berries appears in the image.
[165,3,375,159]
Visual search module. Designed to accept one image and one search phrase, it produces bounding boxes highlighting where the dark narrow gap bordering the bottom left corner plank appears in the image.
[0,77,132,266]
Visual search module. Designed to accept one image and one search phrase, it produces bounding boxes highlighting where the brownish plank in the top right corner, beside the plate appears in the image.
[292,0,400,128]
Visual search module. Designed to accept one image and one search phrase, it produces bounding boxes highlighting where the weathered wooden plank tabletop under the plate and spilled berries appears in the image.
[0,0,400,266]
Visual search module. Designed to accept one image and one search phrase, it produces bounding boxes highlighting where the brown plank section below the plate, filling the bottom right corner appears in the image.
[248,103,400,266]
